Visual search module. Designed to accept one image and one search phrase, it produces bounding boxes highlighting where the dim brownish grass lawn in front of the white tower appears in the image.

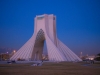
[0,62,100,75]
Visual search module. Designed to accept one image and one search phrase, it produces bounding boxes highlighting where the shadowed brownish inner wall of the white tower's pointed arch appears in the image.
[32,29,45,61]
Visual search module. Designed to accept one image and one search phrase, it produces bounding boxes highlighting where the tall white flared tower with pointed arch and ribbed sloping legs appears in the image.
[10,14,81,61]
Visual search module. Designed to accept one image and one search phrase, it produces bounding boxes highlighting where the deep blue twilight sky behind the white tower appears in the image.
[0,0,100,55]
